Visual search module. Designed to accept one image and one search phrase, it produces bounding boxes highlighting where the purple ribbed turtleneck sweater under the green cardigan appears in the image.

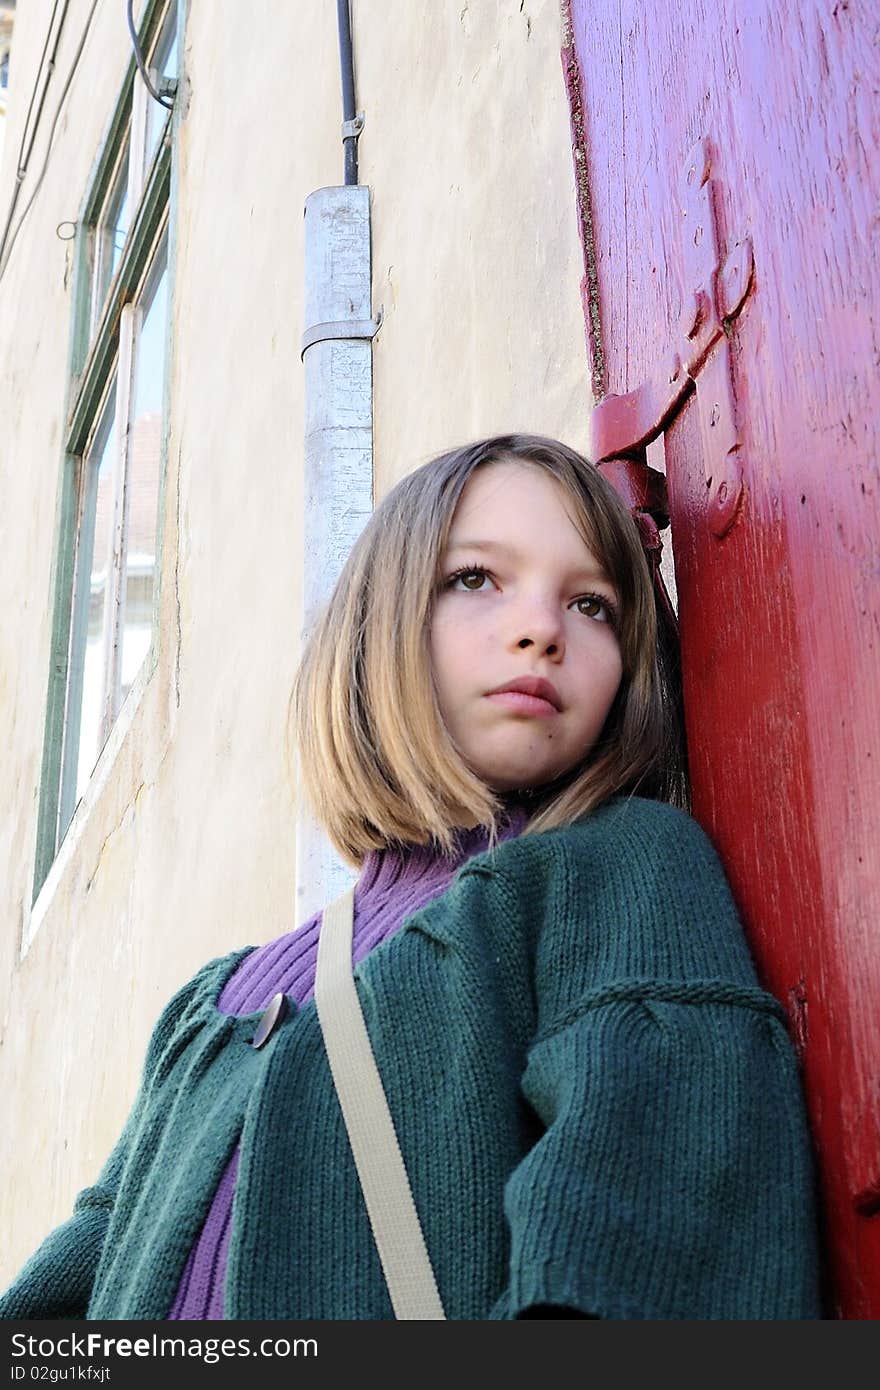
[168,799,528,1321]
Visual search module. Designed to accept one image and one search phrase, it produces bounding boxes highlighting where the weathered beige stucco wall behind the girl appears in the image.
[0,0,588,1284]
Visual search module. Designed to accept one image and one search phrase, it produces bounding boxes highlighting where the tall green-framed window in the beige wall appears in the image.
[33,0,178,899]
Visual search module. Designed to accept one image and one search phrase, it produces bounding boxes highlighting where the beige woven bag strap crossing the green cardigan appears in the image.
[314,888,446,1319]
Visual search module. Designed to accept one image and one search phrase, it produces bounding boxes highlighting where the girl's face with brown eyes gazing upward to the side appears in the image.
[431,461,623,791]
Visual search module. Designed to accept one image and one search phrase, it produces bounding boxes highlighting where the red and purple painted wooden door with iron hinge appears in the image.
[563,0,880,1319]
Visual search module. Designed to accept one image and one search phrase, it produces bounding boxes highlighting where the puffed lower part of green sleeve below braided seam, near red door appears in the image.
[492,991,822,1319]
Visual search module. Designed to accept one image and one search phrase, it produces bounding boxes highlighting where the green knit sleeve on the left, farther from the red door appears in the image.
[0,962,214,1319]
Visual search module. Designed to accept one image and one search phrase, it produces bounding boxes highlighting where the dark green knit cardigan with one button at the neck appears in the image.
[0,798,822,1321]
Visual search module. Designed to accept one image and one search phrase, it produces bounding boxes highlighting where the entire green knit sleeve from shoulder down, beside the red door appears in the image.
[491,799,822,1319]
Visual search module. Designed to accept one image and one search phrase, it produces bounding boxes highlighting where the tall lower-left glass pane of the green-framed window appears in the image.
[67,384,117,801]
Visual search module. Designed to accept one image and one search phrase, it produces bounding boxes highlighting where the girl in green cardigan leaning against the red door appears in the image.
[0,435,820,1319]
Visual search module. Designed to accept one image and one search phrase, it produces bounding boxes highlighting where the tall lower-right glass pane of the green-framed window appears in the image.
[121,239,168,699]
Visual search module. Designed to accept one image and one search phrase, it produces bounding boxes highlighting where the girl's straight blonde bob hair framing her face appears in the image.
[291,434,685,866]
